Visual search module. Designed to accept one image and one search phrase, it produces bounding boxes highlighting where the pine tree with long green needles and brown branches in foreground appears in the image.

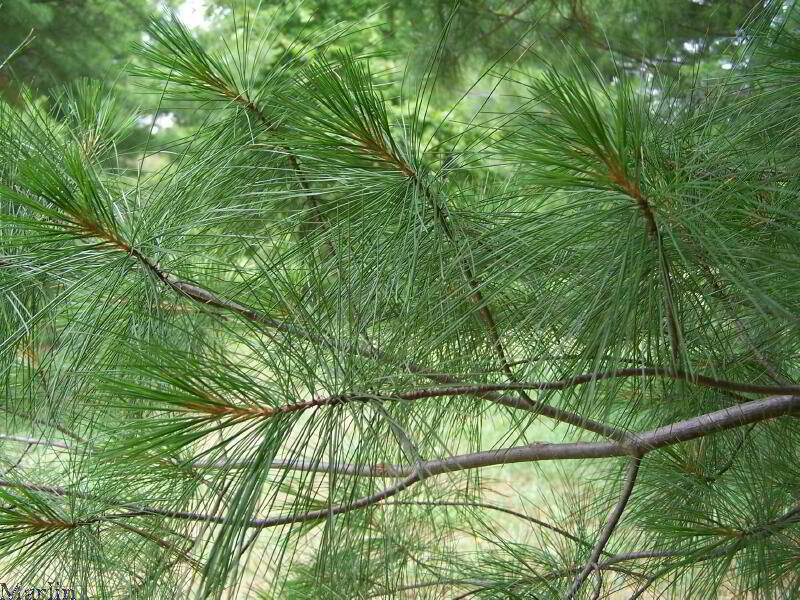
[0,2,800,599]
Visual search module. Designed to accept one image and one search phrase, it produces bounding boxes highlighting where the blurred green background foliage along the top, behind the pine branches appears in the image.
[0,0,761,162]
